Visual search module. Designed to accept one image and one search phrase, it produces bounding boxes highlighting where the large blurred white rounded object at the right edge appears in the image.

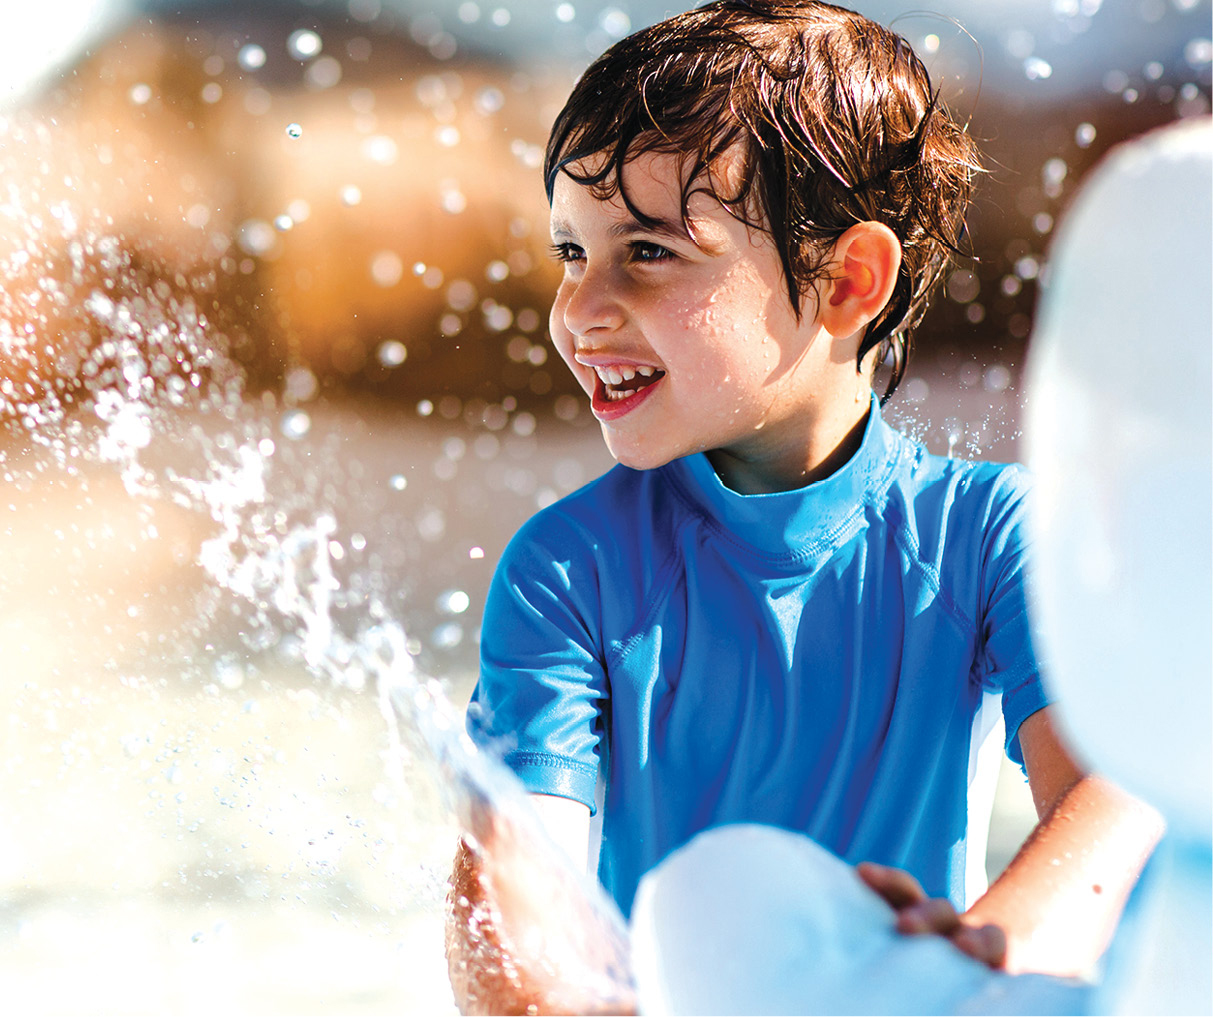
[1025,118,1213,837]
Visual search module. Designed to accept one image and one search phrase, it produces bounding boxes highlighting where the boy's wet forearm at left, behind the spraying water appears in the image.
[446,795,636,1013]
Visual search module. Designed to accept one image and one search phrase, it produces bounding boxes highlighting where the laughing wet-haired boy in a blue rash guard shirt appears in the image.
[449,0,1157,1011]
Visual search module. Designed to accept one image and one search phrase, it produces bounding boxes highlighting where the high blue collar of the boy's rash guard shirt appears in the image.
[671,397,900,553]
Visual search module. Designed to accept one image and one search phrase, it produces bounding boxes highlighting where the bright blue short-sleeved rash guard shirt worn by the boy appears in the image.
[468,402,1046,915]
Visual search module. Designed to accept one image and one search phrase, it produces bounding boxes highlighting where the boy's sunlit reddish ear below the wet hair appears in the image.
[819,222,901,336]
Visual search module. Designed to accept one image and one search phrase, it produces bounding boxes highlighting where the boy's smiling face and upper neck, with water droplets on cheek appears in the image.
[551,148,867,490]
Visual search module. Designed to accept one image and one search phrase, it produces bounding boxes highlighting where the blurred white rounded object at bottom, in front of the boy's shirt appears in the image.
[632,824,1088,1015]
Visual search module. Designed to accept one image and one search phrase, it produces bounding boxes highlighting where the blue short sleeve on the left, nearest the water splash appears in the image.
[467,511,607,811]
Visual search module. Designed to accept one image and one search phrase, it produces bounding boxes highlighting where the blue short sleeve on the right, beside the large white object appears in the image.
[979,466,1048,766]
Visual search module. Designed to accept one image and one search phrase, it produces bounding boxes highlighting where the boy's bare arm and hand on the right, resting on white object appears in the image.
[860,709,1163,976]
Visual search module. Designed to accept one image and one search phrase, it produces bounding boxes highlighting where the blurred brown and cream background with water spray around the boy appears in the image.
[0,0,1213,1013]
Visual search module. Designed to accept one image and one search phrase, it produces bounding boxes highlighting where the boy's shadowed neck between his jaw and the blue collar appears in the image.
[707,393,871,494]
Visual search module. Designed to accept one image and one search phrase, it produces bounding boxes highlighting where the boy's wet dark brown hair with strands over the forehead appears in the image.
[543,0,981,399]
